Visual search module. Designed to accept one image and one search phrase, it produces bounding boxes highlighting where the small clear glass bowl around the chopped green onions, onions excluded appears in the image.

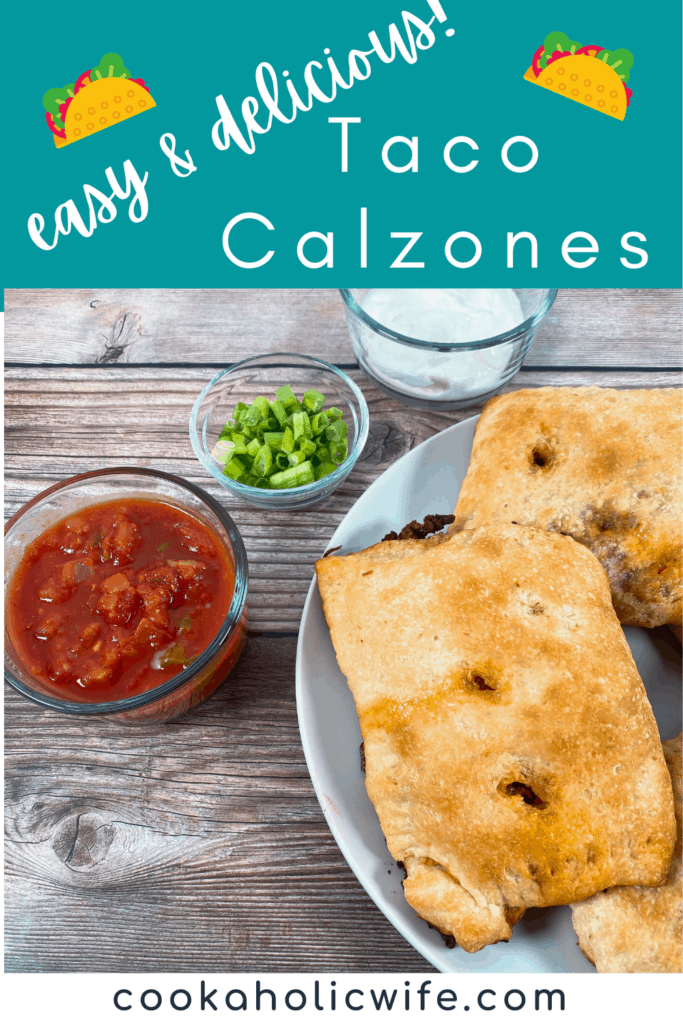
[189,352,369,511]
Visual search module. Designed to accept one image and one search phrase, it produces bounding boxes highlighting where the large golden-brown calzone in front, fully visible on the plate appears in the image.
[316,524,675,951]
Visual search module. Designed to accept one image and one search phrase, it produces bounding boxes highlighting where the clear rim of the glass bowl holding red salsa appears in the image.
[5,466,249,715]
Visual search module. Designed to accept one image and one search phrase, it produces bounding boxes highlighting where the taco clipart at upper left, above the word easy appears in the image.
[43,53,157,148]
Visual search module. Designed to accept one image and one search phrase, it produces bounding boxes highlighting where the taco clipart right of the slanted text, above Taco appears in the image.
[524,32,633,121]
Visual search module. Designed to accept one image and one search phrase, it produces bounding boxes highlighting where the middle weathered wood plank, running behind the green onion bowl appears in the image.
[5,366,680,632]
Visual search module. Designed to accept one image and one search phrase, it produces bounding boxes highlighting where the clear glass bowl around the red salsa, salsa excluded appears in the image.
[5,468,249,724]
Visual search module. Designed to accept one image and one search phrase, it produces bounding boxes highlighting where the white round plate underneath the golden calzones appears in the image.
[296,417,681,973]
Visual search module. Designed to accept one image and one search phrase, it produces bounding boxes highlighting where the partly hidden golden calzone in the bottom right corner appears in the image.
[571,734,683,974]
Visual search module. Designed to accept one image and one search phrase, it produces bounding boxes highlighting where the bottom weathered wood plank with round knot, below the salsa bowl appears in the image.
[5,638,431,972]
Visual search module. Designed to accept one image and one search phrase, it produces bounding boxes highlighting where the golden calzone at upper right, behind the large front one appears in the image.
[453,387,683,626]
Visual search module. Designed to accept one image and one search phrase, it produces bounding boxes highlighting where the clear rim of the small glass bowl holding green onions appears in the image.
[189,352,370,499]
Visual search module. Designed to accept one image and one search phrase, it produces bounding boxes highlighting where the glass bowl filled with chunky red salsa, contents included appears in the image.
[5,468,248,723]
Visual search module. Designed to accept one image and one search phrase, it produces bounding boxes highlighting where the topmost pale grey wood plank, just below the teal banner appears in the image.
[5,289,683,367]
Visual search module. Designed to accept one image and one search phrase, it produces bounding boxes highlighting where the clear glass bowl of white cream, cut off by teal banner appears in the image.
[339,288,557,410]
